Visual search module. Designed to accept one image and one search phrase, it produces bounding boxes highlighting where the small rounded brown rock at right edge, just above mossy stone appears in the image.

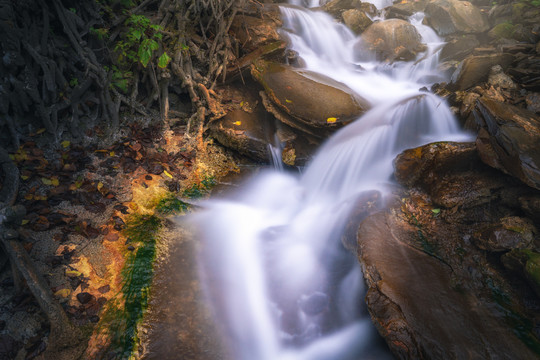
[474,216,538,251]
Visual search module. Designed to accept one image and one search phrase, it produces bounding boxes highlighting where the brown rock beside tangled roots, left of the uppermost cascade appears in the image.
[230,13,281,52]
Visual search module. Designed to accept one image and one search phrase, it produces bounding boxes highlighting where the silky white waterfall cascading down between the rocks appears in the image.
[194,1,467,360]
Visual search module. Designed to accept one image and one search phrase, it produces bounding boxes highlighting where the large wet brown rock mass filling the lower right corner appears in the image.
[358,143,540,359]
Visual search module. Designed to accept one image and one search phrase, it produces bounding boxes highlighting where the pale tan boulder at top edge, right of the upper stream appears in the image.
[425,0,489,36]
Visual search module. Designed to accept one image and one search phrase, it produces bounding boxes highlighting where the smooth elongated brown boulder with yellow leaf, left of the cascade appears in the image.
[251,61,370,133]
